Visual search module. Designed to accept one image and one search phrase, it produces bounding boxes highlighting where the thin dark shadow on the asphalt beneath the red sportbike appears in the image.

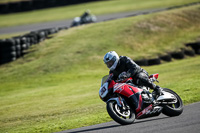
[66,116,170,133]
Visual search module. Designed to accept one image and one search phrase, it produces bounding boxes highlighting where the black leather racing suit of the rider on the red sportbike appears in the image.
[110,56,156,89]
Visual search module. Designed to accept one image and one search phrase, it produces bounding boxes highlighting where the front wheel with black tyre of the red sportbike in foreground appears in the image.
[107,101,135,125]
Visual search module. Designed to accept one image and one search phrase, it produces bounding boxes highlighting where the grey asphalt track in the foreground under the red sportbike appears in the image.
[58,102,200,133]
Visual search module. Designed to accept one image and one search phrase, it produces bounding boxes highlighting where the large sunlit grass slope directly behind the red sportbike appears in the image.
[0,6,200,133]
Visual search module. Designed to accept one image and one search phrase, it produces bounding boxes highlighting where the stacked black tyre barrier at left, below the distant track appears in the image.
[0,27,68,65]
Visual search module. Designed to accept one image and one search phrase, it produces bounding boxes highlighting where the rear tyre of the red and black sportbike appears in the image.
[162,88,183,116]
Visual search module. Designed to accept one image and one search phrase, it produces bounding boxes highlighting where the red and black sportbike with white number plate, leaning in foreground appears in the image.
[99,74,183,125]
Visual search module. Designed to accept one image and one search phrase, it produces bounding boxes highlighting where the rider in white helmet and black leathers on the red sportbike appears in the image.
[103,51,161,95]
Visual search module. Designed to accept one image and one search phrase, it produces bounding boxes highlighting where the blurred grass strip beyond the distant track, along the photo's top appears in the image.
[0,0,200,27]
